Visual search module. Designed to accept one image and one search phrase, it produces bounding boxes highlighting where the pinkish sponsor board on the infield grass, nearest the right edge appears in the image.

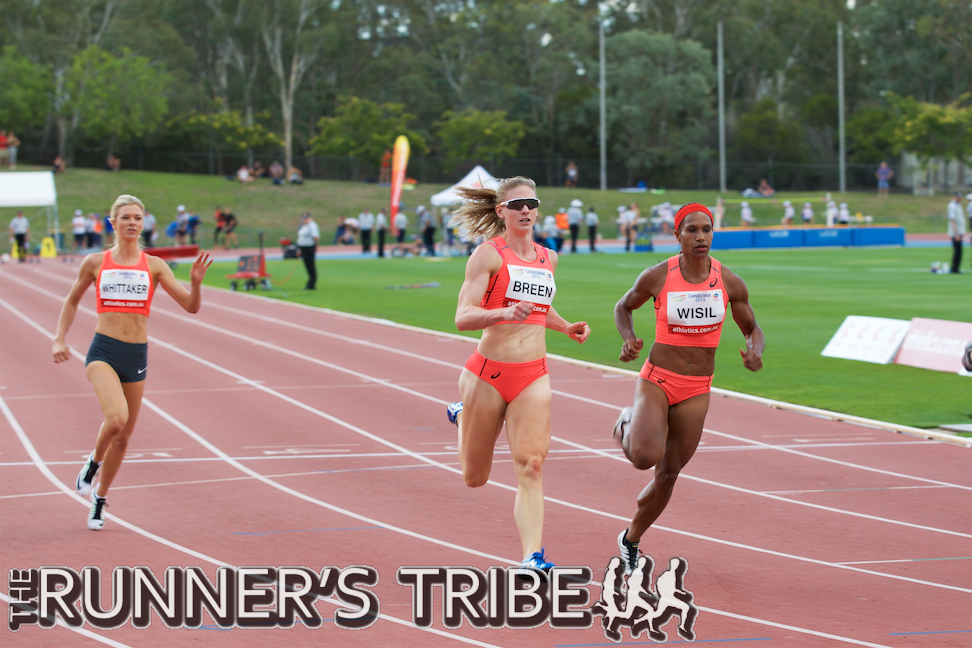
[894,317,972,373]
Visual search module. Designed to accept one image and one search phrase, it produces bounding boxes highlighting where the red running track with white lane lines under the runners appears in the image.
[0,263,972,648]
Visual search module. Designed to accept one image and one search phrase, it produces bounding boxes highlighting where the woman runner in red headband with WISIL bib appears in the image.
[614,203,765,573]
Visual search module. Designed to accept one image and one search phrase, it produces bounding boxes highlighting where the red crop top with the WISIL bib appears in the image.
[655,255,729,347]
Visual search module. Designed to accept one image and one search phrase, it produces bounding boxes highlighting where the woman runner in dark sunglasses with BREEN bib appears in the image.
[447,177,591,571]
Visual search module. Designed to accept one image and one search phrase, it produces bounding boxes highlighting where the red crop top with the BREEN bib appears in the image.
[480,236,557,326]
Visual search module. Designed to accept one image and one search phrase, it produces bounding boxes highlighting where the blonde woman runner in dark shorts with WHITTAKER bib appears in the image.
[53,195,212,531]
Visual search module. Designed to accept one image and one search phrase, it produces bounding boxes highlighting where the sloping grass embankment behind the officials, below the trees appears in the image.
[0,166,949,247]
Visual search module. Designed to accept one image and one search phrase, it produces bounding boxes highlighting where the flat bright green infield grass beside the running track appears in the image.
[178,248,972,427]
